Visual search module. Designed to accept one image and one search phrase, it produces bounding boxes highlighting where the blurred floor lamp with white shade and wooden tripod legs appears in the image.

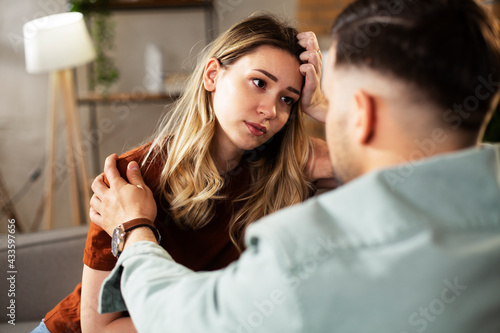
[23,12,95,229]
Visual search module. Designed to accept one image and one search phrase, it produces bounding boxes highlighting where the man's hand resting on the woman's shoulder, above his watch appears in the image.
[90,154,156,235]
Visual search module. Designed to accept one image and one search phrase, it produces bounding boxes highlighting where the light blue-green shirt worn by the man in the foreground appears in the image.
[100,146,500,333]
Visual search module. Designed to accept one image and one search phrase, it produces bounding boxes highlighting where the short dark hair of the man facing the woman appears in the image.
[332,0,500,134]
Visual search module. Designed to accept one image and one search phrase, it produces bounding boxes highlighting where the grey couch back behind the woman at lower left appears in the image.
[0,226,88,323]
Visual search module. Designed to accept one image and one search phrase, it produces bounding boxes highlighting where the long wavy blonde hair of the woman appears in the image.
[142,14,311,250]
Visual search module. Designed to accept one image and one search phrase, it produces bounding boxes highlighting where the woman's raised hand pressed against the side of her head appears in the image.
[297,31,328,123]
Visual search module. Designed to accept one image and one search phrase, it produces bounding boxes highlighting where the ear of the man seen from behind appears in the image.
[354,90,377,144]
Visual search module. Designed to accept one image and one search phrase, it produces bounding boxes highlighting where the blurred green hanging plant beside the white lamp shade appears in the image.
[70,0,119,95]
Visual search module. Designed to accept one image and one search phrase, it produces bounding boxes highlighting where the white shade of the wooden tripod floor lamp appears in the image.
[23,12,95,74]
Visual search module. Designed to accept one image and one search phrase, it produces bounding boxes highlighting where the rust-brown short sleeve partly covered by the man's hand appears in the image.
[83,146,147,271]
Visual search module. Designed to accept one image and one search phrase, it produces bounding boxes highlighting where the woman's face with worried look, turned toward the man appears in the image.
[205,45,303,154]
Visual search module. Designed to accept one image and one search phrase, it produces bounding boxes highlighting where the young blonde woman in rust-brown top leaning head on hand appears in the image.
[33,15,332,333]
